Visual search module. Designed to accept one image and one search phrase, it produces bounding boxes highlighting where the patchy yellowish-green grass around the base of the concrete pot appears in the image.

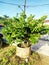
[0,46,47,65]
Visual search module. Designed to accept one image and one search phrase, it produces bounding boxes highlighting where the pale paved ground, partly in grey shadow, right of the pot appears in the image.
[32,40,49,56]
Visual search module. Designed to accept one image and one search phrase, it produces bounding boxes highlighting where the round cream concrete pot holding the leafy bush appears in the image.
[16,44,31,58]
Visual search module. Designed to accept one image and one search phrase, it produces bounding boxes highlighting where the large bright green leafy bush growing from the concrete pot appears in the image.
[2,13,47,44]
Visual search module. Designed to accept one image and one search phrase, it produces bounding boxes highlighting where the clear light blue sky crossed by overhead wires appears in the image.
[0,0,49,19]
